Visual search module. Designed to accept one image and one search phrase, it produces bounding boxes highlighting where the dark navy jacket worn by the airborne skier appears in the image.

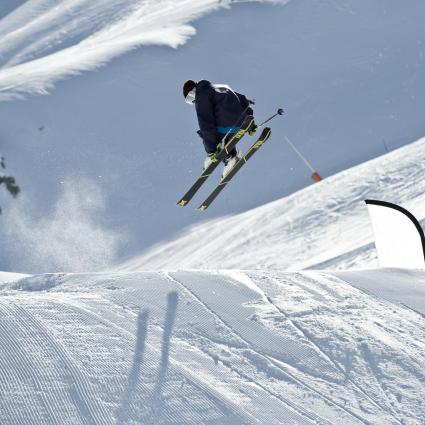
[195,80,253,153]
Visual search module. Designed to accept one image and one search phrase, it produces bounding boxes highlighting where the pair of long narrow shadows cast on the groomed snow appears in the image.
[117,292,178,425]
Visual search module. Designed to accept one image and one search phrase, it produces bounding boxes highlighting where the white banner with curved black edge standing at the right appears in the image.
[365,199,425,269]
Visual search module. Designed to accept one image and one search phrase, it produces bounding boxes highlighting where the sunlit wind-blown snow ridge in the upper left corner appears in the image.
[0,0,287,101]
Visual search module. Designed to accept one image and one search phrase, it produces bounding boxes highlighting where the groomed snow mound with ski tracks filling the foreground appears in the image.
[0,270,425,425]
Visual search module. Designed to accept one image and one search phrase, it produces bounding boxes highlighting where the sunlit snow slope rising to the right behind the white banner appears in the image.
[119,139,425,271]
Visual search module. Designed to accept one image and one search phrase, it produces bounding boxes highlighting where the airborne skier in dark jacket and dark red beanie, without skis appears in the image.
[183,80,256,177]
